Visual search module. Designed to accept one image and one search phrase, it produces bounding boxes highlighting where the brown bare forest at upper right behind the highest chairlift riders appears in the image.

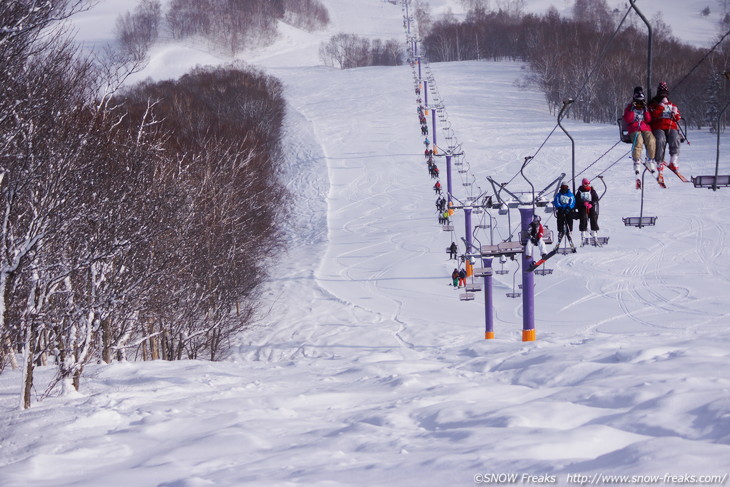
[423,0,730,128]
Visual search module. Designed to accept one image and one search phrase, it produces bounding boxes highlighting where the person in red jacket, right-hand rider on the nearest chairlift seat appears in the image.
[649,81,682,171]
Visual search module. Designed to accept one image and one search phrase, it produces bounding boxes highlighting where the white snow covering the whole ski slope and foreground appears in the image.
[0,0,730,487]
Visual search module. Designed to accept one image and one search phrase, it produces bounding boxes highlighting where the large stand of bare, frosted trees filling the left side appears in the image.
[0,0,286,408]
